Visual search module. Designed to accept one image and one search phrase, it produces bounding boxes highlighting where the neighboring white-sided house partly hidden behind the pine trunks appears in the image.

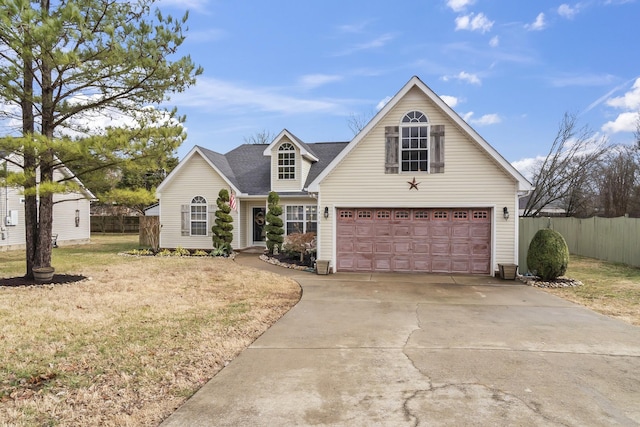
[0,153,95,251]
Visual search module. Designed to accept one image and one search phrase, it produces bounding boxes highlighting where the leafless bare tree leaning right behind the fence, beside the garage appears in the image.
[523,113,607,216]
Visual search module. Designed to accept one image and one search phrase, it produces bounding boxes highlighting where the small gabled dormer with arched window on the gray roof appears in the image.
[263,129,318,192]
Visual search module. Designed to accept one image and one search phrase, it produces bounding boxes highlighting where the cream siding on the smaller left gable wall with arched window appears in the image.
[158,153,239,250]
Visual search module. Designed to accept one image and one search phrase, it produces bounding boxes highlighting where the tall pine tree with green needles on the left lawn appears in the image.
[0,0,202,278]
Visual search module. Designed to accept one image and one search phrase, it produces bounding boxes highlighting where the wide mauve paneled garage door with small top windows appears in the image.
[337,209,491,274]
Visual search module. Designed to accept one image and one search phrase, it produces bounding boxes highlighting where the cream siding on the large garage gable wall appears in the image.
[318,88,518,274]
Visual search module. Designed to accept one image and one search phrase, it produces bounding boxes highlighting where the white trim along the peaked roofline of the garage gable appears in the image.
[309,76,532,192]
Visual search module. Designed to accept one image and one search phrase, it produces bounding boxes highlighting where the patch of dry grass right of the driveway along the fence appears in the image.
[545,255,640,326]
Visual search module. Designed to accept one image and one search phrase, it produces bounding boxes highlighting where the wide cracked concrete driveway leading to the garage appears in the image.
[162,255,640,427]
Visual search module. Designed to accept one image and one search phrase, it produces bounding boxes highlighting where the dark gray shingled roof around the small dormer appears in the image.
[198,142,348,195]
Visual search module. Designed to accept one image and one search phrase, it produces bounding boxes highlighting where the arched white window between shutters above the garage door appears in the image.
[400,111,429,172]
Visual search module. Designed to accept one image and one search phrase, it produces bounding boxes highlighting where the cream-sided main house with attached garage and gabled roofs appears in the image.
[157,77,531,275]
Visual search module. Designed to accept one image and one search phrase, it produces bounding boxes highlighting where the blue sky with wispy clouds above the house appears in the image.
[160,0,640,173]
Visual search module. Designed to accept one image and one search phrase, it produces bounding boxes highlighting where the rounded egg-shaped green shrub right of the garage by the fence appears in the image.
[527,228,569,281]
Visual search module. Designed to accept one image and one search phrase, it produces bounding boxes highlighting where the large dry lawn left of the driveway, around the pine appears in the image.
[0,236,300,426]
